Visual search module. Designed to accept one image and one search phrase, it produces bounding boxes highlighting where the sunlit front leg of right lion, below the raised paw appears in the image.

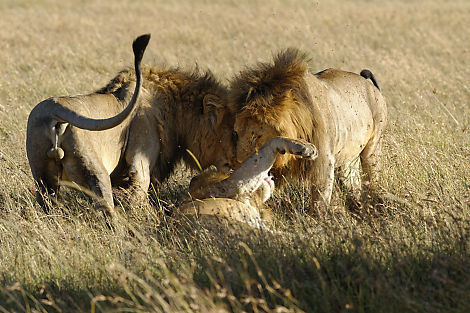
[312,152,335,213]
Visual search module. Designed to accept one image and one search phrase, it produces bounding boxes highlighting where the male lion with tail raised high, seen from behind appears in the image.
[26,36,234,210]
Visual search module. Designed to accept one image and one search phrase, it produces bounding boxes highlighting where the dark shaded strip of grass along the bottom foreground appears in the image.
[0,214,470,312]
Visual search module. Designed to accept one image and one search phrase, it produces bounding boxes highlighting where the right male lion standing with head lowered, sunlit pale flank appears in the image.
[230,49,387,208]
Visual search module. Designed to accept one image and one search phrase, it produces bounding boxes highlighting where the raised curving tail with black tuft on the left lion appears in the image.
[54,34,150,131]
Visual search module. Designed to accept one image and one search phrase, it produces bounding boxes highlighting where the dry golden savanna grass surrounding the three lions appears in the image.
[0,0,470,312]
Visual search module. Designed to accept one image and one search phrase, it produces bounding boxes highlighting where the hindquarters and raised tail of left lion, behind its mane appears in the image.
[26,35,150,208]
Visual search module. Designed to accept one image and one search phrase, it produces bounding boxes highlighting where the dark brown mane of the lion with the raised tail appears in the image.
[97,66,233,180]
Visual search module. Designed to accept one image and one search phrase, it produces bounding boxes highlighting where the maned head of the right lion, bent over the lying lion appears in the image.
[230,49,312,168]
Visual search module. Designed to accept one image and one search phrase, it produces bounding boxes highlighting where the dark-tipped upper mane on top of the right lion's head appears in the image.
[230,48,308,113]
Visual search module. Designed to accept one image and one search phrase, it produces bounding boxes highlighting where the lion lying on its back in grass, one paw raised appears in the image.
[177,137,318,230]
